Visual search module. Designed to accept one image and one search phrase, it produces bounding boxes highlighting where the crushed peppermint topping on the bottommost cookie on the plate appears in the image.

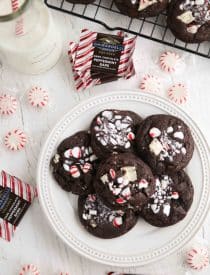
[82,194,125,228]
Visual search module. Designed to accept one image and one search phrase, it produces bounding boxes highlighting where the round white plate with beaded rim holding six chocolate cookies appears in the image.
[37,91,210,267]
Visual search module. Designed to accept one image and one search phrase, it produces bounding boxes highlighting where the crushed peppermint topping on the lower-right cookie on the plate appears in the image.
[148,175,179,217]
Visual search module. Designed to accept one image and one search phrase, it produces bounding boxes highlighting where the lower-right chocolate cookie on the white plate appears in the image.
[141,171,194,227]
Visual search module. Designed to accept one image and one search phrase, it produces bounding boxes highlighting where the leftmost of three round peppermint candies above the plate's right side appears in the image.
[140,74,161,93]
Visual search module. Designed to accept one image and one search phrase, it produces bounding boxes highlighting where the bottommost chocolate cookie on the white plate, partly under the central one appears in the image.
[78,194,137,239]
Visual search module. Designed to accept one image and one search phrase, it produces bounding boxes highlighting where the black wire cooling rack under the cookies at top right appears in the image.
[44,0,210,58]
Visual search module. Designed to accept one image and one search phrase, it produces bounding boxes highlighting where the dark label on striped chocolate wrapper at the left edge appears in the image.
[0,186,30,226]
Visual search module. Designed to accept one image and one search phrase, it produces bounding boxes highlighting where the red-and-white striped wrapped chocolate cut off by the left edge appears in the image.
[0,171,37,241]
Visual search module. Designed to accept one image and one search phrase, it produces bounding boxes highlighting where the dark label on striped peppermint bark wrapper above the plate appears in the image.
[91,33,124,76]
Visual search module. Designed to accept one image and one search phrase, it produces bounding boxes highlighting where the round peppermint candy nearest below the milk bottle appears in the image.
[28,86,49,108]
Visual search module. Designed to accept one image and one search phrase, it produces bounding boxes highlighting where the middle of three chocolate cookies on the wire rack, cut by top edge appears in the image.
[115,0,169,17]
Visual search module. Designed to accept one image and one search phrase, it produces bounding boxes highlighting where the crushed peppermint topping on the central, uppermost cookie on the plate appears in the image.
[100,166,149,204]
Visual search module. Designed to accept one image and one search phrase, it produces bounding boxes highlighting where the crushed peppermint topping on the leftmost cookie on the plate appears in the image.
[60,146,97,178]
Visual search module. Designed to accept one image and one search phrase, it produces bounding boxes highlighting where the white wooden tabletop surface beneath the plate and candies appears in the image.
[0,6,210,275]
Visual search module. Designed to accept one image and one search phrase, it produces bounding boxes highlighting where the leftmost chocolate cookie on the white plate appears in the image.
[51,131,97,195]
